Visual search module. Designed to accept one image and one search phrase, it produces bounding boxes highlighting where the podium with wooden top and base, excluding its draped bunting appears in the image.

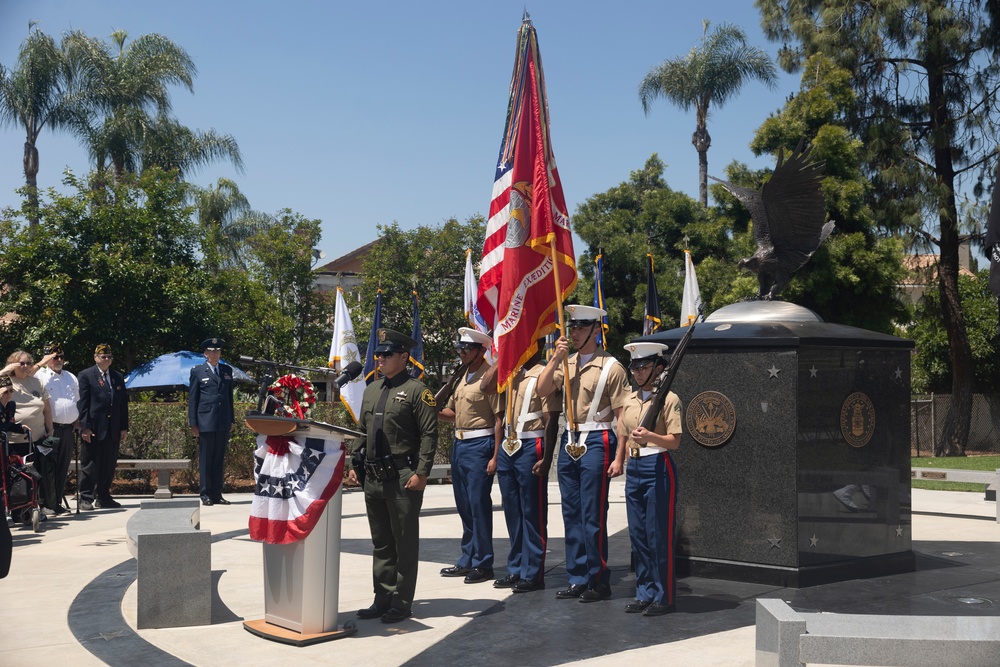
[243,412,361,646]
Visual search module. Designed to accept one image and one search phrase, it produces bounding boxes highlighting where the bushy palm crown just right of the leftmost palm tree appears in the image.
[66,30,243,179]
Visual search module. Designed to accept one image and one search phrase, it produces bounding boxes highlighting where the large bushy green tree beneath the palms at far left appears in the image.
[0,169,211,369]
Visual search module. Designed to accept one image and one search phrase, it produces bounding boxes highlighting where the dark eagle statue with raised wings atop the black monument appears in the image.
[712,141,834,301]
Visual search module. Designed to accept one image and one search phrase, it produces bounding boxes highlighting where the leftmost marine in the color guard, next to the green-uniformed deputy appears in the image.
[438,327,500,584]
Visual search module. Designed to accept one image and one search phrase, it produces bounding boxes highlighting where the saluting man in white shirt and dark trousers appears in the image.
[35,342,80,514]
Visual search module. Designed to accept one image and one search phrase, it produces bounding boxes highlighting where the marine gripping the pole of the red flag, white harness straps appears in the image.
[537,305,630,602]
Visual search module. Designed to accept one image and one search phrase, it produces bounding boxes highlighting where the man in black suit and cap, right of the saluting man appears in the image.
[77,343,128,510]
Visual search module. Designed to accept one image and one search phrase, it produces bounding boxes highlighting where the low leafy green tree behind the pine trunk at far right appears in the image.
[903,270,1000,393]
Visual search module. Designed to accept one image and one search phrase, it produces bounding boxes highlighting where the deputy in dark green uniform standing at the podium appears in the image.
[348,329,438,623]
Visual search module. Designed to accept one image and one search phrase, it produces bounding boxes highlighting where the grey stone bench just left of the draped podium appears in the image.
[125,499,212,629]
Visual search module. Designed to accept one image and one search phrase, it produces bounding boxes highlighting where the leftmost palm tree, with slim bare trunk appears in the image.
[0,23,78,229]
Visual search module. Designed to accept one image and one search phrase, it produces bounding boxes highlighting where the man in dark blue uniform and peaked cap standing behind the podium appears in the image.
[188,338,236,505]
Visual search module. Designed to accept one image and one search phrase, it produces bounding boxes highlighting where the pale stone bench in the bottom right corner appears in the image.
[755,599,1000,667]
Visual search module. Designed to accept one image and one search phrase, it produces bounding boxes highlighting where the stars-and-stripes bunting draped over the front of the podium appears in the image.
[250,435,344,544]
